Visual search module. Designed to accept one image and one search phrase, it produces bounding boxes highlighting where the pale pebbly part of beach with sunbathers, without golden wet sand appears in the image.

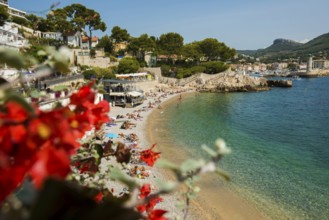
[103,88,191,219]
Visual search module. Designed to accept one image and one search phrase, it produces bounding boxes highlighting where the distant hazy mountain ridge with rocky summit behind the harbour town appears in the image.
[237,33,329,58]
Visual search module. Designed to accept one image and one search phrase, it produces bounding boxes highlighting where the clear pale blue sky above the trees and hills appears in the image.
[9,0,329,49]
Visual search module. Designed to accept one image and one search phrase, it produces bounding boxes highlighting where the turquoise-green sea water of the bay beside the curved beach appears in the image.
[161,77,329,219]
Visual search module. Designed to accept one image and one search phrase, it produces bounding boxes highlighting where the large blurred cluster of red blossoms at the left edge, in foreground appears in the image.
[0,84,110,202]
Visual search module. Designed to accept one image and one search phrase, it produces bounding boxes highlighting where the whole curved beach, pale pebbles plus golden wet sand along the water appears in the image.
[104,83,266,220]
